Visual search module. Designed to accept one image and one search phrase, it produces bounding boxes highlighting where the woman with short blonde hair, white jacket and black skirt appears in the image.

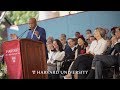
[65,28,107,79]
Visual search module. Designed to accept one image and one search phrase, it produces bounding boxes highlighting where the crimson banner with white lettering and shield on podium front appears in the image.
[2,40,22,79]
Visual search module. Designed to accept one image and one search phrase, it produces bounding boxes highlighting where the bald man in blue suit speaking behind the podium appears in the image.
[26,18,46,45]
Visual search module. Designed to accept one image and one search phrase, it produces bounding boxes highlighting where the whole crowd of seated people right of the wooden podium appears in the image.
[47,27,120,79]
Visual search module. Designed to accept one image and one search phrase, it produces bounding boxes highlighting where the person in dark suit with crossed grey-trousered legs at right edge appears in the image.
[87,27,120,79]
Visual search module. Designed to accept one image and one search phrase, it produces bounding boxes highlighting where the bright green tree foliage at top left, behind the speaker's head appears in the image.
[6,11,39,25]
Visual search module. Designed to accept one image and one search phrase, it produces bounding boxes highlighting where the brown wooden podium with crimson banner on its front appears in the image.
[2,39,48,79]
